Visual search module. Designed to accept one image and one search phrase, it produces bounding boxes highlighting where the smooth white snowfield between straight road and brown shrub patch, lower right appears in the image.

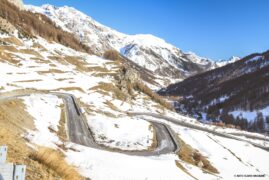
[178,128,269,179]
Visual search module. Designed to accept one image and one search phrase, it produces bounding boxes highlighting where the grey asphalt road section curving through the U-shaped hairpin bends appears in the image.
[0,92,180,156]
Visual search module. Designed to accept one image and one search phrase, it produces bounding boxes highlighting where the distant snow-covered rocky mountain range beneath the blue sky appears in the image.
[26,5,233,79]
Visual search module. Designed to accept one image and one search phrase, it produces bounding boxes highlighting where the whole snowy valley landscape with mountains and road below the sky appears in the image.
[0,0,269,180]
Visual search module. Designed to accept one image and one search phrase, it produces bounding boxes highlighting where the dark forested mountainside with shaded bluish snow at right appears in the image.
[159,51,269,132]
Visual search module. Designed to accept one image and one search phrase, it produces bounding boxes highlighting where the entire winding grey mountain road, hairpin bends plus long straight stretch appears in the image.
[0,92,269,156]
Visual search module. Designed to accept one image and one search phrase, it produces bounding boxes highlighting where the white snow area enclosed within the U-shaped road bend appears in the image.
[87,115,153,150]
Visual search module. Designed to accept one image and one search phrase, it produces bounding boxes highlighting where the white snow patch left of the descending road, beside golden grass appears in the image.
[21,94,63,148]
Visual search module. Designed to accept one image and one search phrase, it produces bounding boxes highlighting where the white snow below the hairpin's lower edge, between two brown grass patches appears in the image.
[66,146,195,180]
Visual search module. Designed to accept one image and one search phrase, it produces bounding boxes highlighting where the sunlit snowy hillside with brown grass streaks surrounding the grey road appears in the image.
[0,21,269,180]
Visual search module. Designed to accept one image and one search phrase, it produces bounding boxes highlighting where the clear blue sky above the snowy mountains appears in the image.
[24,0,269,60]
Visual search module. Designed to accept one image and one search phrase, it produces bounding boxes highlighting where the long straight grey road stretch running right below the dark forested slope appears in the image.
[128,112,269,151]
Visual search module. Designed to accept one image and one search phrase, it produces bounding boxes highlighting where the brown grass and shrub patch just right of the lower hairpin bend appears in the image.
[178,134,219,174]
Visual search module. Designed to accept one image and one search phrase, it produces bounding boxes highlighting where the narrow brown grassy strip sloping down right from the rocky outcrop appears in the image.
[134,82,174,111]
